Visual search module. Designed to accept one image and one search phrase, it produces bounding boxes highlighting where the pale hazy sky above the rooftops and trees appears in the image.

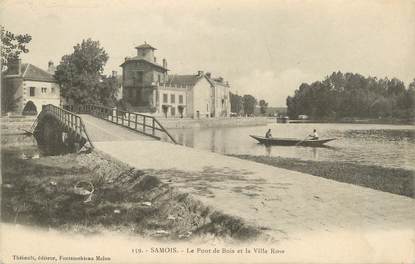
[0,0,415,106]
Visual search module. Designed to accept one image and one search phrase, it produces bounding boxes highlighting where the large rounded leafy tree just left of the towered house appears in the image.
[55,39,117,105]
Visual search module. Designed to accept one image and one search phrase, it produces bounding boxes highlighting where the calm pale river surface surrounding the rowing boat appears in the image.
[164,123,415,170]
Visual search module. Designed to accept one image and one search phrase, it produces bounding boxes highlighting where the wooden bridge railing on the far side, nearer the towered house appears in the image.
[80,105,177,144]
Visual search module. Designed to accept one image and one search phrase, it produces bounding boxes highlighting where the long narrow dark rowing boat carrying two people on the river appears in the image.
[250,135,335,147]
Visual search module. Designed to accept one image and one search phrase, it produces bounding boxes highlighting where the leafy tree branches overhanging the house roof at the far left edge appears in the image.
[1,27,32,71]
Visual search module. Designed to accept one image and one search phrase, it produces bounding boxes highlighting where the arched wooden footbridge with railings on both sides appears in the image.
[32,104,176,151]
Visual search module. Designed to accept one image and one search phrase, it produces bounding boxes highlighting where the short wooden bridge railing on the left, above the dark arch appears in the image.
[42,104,94,148]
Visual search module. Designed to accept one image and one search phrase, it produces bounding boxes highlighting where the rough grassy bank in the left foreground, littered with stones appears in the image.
[1,148,260,240]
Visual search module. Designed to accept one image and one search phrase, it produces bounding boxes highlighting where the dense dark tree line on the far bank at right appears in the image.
[287,71,415,120]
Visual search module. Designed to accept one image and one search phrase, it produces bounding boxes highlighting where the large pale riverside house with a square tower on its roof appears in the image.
[121,43,230,118]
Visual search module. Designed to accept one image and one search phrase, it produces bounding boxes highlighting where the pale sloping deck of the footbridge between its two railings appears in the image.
[80,115,155,142]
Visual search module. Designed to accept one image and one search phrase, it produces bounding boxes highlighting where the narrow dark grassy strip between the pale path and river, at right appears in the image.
[231,155,415,198]
